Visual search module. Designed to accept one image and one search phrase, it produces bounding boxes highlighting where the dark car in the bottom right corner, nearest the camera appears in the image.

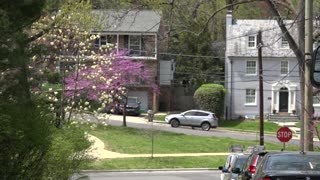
[252,152,320,180]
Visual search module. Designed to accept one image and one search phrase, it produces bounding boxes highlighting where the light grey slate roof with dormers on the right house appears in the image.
[226,19,298,58]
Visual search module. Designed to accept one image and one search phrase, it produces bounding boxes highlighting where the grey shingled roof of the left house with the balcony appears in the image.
[93,10,161,33]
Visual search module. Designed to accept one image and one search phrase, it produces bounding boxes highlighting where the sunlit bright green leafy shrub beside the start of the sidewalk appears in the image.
[45,125,91,179]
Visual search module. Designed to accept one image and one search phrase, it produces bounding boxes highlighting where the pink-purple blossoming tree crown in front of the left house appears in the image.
[64,52,158,125]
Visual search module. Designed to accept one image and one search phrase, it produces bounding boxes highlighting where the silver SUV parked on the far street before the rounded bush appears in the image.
[165,110,218,131]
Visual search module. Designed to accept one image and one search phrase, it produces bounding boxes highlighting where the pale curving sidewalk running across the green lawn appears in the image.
[88,134,229,159]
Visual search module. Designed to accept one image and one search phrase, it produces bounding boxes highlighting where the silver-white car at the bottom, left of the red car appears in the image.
[219,153,249,180]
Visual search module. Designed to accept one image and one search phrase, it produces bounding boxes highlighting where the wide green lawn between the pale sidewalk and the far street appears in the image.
[89,126,298,154]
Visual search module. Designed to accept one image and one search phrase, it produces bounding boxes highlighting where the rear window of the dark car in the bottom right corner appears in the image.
[267,154,320,171]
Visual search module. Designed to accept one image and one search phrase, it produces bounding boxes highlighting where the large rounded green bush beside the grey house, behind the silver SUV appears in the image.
[193,84,226,117]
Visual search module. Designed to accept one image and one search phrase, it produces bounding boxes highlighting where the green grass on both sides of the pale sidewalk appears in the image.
[83,126,299,170]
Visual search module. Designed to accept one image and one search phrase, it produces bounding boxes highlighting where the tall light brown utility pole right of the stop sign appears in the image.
[303,0,313,151]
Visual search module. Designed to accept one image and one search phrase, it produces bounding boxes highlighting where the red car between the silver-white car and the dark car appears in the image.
[238,151,267,180]
